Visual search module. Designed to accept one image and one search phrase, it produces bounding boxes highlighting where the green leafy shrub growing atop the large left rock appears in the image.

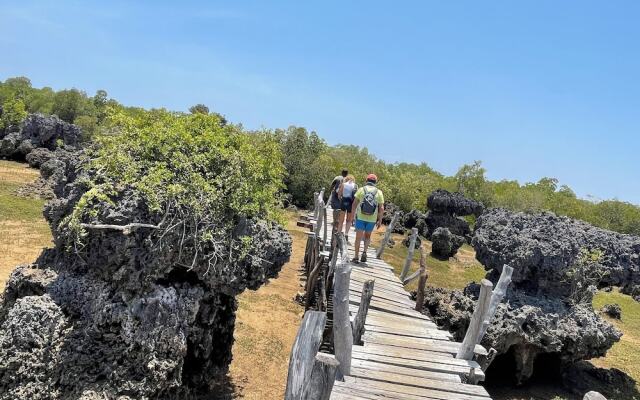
[63,109,284,247]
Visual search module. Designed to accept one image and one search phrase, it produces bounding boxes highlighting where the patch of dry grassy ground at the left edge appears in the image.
[0,160,51,290]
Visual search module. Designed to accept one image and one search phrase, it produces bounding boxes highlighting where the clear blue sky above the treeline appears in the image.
[0,0,640,204]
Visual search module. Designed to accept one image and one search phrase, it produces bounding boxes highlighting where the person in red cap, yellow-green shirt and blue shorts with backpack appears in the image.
[351,174,384,263]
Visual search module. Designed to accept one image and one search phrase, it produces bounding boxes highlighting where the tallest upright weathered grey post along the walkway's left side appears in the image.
[333,235,353,380]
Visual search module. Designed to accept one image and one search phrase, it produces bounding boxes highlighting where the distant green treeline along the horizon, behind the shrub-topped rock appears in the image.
[0,77,640,235]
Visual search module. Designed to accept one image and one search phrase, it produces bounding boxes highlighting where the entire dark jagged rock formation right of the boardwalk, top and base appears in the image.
[416,209,640,383]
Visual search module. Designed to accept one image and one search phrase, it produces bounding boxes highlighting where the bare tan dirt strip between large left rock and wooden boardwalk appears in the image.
[230,214,306,400]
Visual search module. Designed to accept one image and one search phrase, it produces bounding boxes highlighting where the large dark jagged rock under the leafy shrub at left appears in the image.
[0,149,291,400]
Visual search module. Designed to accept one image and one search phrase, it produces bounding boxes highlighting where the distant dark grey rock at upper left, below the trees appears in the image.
[0,114,81,159]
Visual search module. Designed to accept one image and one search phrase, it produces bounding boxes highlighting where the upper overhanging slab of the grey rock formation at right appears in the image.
[473,209,640,297]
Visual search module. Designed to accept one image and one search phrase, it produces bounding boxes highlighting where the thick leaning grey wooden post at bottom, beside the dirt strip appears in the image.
[284,311,327,400]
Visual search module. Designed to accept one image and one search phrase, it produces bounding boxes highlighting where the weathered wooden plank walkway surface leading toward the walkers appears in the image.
[318,209,490,400]
